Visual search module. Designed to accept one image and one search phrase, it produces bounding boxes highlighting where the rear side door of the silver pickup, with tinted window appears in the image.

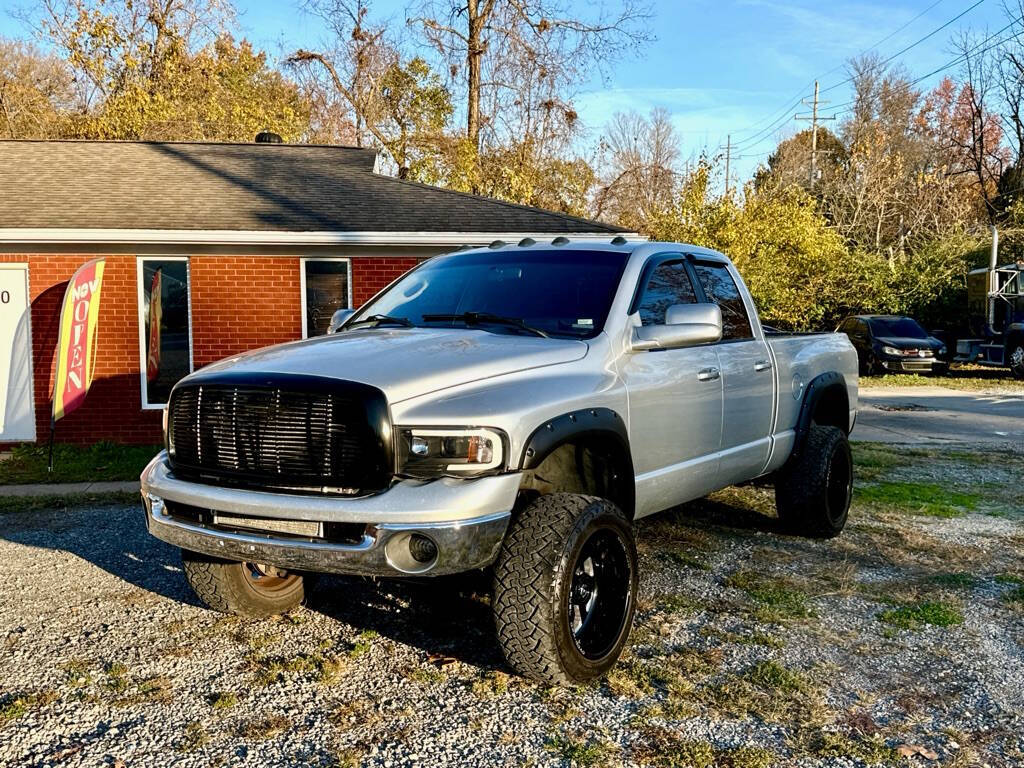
[693,259,775,485]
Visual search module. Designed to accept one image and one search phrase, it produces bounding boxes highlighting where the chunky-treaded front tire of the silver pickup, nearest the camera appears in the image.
[492,494,637,686]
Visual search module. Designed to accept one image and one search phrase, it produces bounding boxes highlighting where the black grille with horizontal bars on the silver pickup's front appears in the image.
[168,375,392,495]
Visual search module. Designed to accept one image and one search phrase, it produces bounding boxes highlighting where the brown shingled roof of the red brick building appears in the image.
[0,140,622,234]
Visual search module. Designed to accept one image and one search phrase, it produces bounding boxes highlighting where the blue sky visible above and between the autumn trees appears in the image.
[0,0,1006,178]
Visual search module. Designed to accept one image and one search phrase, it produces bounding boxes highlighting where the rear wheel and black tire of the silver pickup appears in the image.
[775,424,853,539]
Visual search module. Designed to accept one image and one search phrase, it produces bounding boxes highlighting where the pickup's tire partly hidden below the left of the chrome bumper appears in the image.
[181,549,307,618]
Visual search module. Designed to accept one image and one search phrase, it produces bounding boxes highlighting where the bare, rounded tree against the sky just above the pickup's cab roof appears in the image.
[593,109,679,230]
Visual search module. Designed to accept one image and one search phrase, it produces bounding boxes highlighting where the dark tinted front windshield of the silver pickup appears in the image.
[346,249,628,338]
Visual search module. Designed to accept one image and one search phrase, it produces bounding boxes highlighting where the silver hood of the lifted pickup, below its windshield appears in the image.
[188,328,588,402]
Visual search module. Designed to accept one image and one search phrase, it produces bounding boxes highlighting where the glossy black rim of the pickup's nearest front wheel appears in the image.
[567,528,633,660]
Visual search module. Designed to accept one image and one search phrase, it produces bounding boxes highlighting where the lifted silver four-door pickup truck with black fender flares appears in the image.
[141,238,857,684]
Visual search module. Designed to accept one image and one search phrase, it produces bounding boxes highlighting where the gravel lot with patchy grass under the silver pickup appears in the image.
[0,445,1024,768]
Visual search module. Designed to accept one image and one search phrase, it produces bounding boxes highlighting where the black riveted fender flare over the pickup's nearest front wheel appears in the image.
[519,408,636,517]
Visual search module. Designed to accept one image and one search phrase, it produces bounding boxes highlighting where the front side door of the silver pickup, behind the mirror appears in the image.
[621,256,722,516]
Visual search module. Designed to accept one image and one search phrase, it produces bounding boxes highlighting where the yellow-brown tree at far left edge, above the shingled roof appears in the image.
[0,38,74,138]
